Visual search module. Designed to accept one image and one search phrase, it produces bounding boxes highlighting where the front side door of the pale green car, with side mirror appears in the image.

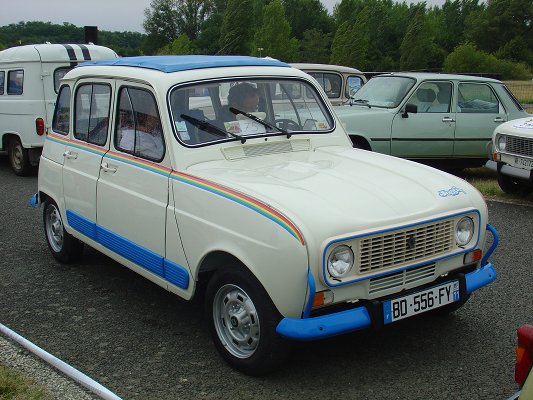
[391,81,455,159]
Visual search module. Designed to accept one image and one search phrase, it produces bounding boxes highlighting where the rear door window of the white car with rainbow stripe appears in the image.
[74,84,111,146]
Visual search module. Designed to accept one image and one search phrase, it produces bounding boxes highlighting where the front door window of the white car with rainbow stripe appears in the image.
[115,87,165,161]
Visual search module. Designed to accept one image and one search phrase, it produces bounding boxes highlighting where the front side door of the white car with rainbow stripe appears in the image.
[96,82,171,279]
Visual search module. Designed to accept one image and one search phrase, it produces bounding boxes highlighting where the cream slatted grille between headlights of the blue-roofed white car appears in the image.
[358,220,454,274]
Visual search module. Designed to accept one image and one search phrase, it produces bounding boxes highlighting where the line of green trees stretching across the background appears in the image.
[0,0,533,79]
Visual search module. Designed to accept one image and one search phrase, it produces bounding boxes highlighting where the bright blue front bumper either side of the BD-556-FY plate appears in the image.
[276,263,496,340]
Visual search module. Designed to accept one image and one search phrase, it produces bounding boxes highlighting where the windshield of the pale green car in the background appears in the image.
[351,76,415,108]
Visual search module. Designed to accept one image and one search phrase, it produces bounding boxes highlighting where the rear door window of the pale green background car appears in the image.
[457,83,500,114]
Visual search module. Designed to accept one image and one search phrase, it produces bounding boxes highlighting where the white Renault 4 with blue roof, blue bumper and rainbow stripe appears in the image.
[33,56,497,375]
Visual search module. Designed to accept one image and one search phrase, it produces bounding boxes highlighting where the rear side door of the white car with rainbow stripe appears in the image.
[63,80,112,239]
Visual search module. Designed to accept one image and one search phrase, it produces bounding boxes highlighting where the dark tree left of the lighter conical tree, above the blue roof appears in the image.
[219,0,254,55]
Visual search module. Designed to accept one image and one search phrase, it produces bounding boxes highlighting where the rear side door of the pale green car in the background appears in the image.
[454,82,507,158]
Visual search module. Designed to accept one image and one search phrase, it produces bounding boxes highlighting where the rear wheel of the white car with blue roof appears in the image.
[43,200,83,264]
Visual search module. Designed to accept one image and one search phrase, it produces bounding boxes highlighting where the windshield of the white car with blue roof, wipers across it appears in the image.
[169,78,333,146]
